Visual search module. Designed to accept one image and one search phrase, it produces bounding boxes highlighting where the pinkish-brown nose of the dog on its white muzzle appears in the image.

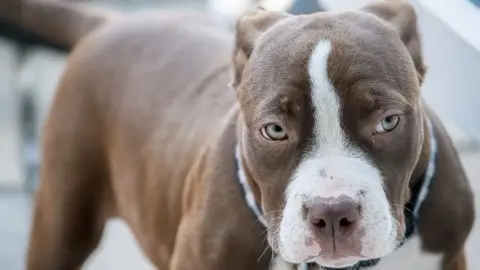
[305,196,360,239]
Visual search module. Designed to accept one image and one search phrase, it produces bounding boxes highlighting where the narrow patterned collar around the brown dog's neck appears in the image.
[235,119,437,270]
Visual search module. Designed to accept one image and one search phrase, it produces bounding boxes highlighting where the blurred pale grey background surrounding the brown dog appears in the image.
[0,0,480,270]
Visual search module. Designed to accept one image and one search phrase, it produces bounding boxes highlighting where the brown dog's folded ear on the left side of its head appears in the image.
[230,7,291,89]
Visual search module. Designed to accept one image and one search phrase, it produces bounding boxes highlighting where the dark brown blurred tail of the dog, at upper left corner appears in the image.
[0,0,120,49]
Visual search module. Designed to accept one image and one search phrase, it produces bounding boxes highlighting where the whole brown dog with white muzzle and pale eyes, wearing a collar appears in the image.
[12,0,474,270]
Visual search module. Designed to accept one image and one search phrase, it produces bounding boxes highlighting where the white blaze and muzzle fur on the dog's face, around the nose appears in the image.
[279,41,397,267]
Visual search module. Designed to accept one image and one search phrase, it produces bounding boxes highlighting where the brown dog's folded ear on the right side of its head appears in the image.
[362,0,427,83]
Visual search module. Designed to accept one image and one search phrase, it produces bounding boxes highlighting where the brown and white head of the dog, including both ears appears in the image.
[232,2,424,267]
